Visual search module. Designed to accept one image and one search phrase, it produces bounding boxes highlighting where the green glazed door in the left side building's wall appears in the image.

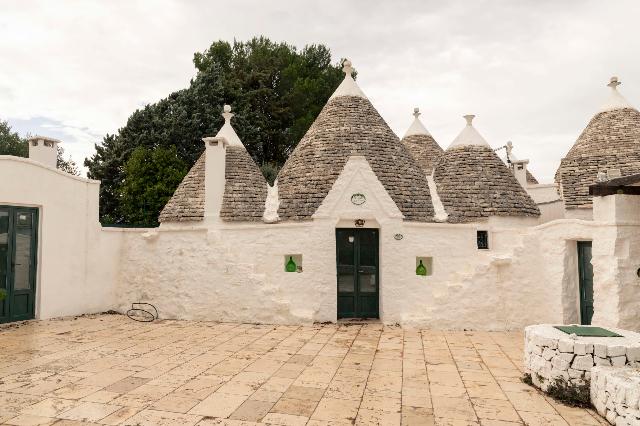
[0,206,38,322]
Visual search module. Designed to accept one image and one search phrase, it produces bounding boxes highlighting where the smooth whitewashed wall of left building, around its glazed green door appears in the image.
[0,156,120,318]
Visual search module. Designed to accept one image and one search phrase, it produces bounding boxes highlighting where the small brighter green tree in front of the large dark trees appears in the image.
[119,146,188,226]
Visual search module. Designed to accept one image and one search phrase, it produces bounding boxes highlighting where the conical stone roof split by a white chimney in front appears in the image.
[159,105,267,222]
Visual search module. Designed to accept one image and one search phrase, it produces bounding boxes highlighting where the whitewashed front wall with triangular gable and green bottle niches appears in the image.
[110,157,596,330]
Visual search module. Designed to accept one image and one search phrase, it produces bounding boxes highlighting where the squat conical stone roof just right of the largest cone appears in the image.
[434,116,540,223]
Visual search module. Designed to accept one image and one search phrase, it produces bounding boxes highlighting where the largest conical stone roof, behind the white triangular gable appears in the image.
[278,61,433,221]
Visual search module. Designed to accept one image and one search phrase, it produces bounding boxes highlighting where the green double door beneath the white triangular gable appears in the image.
[336,229,379,318]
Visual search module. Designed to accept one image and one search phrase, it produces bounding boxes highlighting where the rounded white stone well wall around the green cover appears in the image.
[524,324,640,390]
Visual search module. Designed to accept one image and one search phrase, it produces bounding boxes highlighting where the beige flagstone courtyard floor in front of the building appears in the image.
[0,315,605,426]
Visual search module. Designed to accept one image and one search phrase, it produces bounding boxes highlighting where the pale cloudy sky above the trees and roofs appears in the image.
[0,0,640,181]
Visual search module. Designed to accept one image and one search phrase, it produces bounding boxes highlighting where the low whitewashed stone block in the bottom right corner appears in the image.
[591,366,640,426]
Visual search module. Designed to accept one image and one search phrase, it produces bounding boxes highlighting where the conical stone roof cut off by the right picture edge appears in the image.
[555,77,640,209]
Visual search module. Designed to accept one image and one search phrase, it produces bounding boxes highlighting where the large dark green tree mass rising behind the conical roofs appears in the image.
[85,37,343,223]
